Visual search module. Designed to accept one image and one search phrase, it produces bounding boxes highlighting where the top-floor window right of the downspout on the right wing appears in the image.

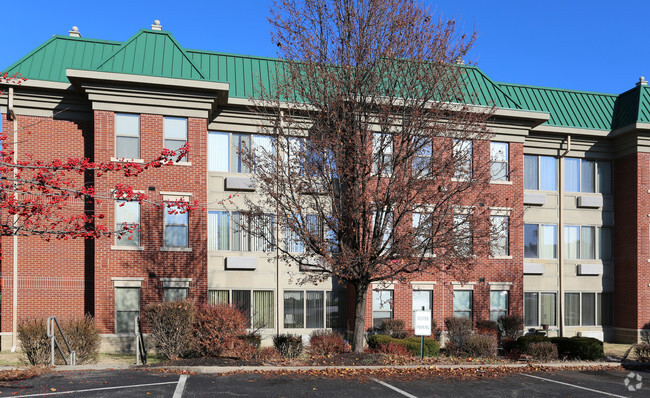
[564,158,612,194]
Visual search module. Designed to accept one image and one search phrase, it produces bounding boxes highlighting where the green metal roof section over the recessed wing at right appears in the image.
[501,83,617,130]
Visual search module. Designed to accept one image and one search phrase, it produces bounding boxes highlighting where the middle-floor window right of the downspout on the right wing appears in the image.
[564,225,612,261]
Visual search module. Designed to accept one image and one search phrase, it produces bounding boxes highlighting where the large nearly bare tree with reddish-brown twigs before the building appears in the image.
[246,0,502,352]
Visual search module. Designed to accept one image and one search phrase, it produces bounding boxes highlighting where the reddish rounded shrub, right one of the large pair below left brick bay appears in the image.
[193,304,248,357]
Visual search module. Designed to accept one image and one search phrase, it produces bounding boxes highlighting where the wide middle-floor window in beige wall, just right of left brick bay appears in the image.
[208,211,275,252]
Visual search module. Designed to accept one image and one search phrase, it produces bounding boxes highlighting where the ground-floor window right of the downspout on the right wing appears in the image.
[564,292,612,326]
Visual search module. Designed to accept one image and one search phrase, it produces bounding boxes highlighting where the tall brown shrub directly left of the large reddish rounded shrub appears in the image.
[144,301,194,359]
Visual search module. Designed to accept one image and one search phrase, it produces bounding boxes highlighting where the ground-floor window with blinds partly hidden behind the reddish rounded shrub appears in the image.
[208,289,275,329]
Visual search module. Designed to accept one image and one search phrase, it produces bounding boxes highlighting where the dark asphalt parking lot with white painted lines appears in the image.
[0,369,650,398]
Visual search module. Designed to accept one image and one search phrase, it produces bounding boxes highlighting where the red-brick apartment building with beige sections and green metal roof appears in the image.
[0,25,650,350]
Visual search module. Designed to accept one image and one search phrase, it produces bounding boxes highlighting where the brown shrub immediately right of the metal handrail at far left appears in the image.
[61,315,102,365]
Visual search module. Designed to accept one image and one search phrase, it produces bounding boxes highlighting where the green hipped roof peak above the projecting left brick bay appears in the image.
[96,29,205,80]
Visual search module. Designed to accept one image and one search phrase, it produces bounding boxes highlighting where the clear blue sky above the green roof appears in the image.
[0,0,650,93]
